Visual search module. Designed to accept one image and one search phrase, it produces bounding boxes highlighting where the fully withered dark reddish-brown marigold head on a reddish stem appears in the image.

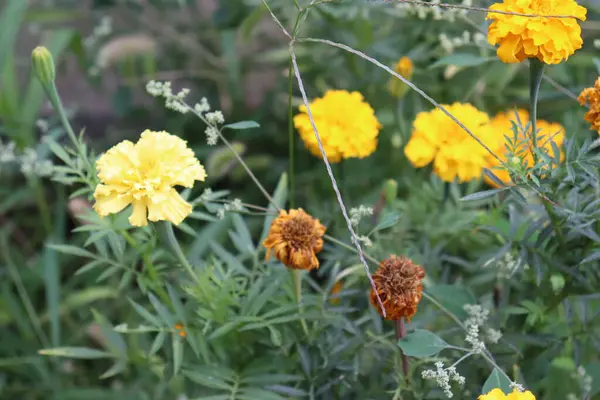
[371,255,425,322]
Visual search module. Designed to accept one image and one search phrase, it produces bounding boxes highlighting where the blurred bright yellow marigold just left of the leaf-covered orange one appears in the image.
[404,103,503,182]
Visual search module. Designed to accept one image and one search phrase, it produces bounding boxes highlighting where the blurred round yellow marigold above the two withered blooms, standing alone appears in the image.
[294,90,381,163]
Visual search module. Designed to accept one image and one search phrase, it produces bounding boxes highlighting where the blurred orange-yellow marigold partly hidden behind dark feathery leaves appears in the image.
[484,109,565,186]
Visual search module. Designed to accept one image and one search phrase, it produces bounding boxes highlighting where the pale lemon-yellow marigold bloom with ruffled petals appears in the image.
[94,130,206,226]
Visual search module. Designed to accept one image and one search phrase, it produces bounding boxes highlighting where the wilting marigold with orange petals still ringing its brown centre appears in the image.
[263,208,325,270]
